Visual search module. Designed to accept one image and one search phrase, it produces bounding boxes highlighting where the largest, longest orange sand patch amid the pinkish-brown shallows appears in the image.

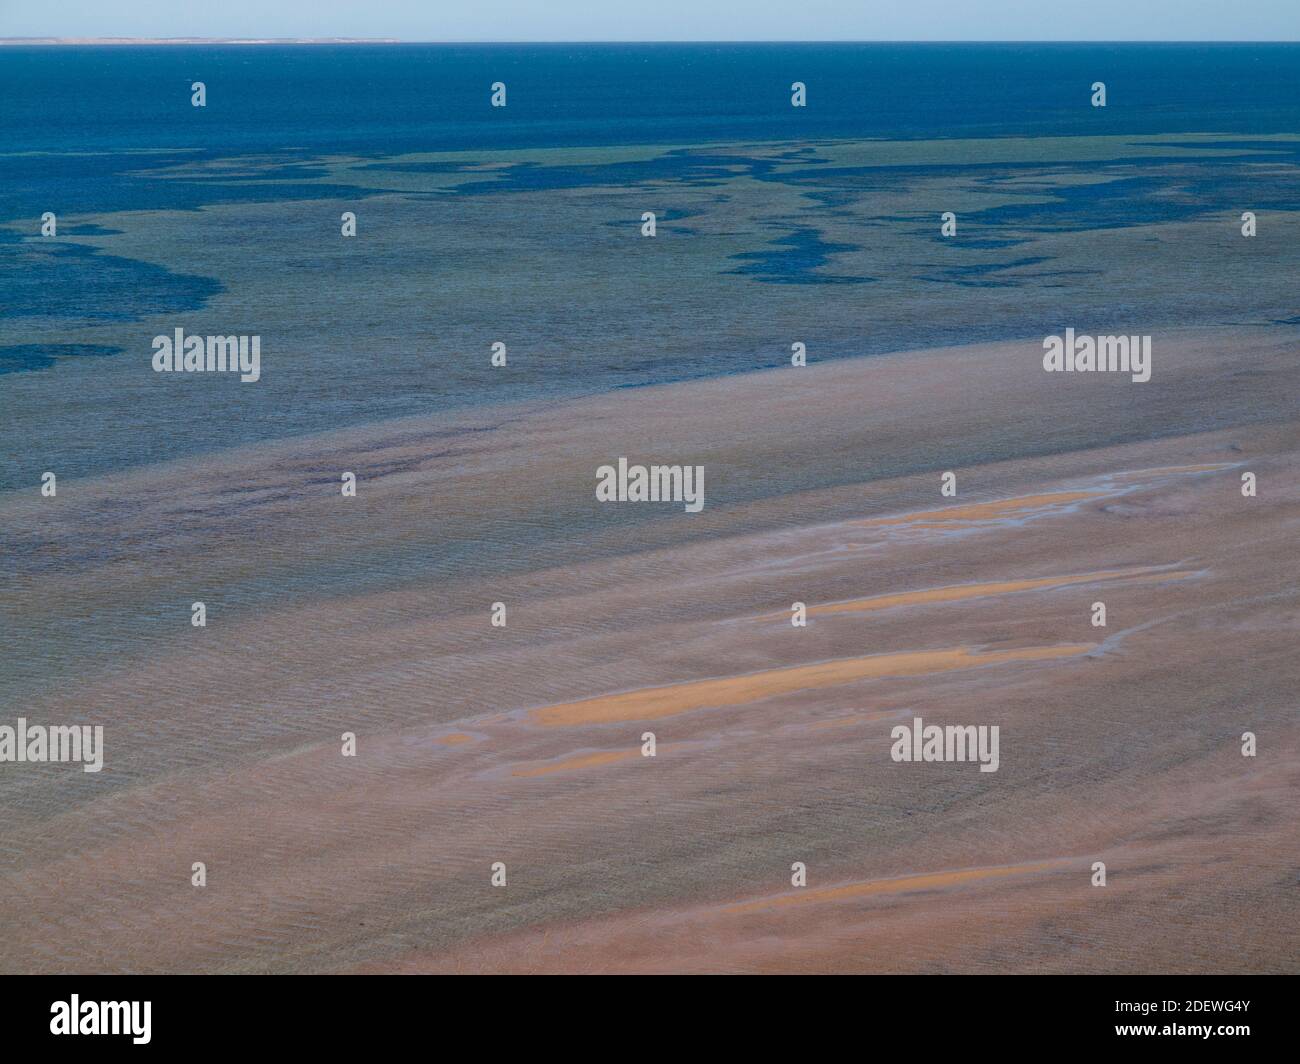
[529,643,1097,726]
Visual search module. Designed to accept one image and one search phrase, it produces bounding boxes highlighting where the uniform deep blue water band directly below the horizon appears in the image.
[0,44,1300,221]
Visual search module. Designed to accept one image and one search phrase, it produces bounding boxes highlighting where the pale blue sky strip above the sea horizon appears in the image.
[0,0,1300,40]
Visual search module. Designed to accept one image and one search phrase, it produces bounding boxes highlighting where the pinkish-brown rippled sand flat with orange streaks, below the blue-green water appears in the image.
[0,329,1300,972]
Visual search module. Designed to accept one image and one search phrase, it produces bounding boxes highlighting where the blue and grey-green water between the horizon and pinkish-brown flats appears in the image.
[0,44,1300,488]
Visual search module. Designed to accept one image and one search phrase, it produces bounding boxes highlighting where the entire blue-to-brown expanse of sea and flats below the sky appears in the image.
[0,43,1300,973]
